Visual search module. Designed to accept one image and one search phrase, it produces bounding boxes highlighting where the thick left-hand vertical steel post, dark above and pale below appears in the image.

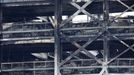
[54,0,62,75]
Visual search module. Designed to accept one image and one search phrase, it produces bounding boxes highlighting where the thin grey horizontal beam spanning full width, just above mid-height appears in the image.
[2,26,134,34]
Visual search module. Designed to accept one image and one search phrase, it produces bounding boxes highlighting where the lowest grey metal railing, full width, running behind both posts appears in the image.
[1,58,134,73]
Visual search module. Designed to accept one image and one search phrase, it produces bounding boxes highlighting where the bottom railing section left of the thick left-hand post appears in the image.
[1,61,54,71]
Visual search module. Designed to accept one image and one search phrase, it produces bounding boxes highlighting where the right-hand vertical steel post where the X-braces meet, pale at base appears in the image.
[103,0,109,75]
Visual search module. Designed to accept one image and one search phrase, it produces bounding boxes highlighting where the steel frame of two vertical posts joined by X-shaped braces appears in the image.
[0,0,134,75]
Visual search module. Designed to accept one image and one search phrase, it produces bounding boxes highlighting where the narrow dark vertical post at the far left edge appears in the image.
[0,2,2,75]
